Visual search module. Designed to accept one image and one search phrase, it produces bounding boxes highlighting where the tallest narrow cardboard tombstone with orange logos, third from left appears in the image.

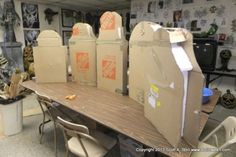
[97,12,128,94]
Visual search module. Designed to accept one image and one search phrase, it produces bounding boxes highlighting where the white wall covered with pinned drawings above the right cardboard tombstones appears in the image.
[131,0,236,33]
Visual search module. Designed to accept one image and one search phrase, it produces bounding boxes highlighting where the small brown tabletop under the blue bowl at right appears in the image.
[202,90,221,114]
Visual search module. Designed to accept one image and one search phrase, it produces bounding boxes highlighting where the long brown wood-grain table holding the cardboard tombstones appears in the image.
[21,81,212,157]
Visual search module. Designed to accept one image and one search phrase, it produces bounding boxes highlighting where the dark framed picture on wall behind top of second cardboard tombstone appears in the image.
[61,9,79,28]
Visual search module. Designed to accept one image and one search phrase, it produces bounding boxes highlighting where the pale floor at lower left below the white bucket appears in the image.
[0,115,68,157]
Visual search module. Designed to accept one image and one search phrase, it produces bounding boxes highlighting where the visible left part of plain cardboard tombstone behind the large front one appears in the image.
[129,22,161,105]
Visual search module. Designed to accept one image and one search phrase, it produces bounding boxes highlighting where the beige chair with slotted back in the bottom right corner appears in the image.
[191,116,236,157]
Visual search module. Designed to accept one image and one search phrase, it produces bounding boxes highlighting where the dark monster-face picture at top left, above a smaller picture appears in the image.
[21,3,39,28]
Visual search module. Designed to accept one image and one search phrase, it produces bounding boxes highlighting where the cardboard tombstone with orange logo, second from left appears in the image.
[69,23,97,86]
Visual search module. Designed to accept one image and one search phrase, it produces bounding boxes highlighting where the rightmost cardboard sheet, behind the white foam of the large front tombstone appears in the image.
[182,30,204,148]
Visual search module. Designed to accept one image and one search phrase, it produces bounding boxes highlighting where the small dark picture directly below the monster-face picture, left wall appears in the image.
[24,30,40,46]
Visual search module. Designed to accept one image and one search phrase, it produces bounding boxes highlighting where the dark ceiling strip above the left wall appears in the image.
[20,0,131,11]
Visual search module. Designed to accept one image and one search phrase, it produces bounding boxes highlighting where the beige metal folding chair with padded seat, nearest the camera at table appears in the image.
[57,117,117,157]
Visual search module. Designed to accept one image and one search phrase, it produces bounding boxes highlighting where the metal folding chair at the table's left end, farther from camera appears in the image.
[35,91,82,156]
